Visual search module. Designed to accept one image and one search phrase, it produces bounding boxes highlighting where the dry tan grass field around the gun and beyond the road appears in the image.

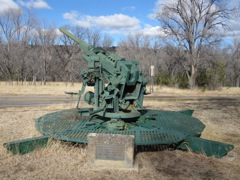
[0,82,240,179]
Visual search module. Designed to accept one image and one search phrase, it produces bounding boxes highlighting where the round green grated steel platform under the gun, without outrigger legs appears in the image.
[36,109,205,145]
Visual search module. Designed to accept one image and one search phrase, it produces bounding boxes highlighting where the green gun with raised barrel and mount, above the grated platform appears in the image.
[60,28,147,120]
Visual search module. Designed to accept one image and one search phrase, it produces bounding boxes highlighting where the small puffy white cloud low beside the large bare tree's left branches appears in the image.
[139,24,166,37]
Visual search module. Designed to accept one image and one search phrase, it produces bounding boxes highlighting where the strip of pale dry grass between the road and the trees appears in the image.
[0,81,240,96]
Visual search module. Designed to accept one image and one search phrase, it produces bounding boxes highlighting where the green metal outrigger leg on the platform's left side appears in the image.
[3,136,49,154]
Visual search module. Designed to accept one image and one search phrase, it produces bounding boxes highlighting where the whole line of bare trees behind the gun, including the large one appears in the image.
[0,0,240,89]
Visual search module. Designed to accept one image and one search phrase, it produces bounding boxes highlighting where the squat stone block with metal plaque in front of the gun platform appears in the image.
[86,133,136,169]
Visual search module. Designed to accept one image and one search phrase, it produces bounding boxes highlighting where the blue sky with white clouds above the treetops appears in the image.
[0,0,240,45]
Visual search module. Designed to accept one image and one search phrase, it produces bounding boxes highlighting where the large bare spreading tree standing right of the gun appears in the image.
[156,0,234,88]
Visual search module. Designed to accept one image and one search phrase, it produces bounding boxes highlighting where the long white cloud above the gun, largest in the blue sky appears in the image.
[63,11,140,33]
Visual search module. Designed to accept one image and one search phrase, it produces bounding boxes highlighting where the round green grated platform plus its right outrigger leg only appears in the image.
[33,109,234,158]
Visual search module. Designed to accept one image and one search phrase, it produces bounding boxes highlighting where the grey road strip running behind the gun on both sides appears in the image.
[0,95,240,108]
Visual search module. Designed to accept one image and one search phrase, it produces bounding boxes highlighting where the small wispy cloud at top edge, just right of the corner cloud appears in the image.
[17,0,52,9]
